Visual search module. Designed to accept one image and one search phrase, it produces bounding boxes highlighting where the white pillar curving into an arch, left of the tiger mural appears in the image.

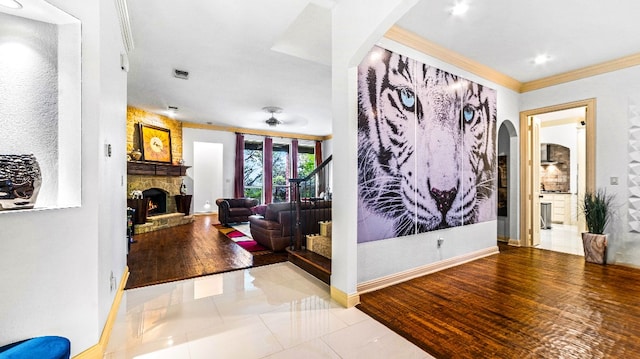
[331,0,417,298]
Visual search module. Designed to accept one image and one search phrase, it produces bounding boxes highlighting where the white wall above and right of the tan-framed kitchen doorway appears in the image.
[520,66,640,265]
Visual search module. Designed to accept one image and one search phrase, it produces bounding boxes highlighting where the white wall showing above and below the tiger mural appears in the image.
[358,39,519,283]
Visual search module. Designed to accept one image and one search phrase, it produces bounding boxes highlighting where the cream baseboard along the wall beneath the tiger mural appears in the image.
[357,246,500,294]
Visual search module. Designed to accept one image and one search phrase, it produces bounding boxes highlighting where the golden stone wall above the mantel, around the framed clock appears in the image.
[127,106,182,164]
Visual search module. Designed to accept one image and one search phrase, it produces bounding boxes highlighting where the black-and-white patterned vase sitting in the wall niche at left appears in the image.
[0,155,42,211]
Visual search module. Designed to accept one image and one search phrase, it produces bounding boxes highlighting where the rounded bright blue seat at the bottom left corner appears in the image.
[0,336,71,359]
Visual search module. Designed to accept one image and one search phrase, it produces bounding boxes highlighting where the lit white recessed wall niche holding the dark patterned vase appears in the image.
[0,0,81,214]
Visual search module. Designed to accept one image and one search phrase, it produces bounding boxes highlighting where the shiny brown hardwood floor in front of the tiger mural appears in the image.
[358,245,640,358]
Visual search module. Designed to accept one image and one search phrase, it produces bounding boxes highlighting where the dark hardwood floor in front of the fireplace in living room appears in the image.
[126,215,286,289]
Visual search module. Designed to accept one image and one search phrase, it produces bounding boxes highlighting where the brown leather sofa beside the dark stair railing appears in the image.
[249,201,331,252]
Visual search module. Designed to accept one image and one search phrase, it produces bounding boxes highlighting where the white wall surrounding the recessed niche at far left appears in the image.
[0,0,126,355]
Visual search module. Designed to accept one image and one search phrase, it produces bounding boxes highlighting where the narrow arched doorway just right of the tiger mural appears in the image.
[497,120,520,245]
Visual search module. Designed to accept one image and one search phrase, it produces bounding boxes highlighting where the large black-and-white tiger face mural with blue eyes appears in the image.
[358,47,497,242]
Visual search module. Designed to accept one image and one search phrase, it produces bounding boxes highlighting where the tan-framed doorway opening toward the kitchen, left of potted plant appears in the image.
[520,99,596,249]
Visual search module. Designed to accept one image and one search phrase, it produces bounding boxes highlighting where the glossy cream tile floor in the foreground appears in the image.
[104,263,432,359]
